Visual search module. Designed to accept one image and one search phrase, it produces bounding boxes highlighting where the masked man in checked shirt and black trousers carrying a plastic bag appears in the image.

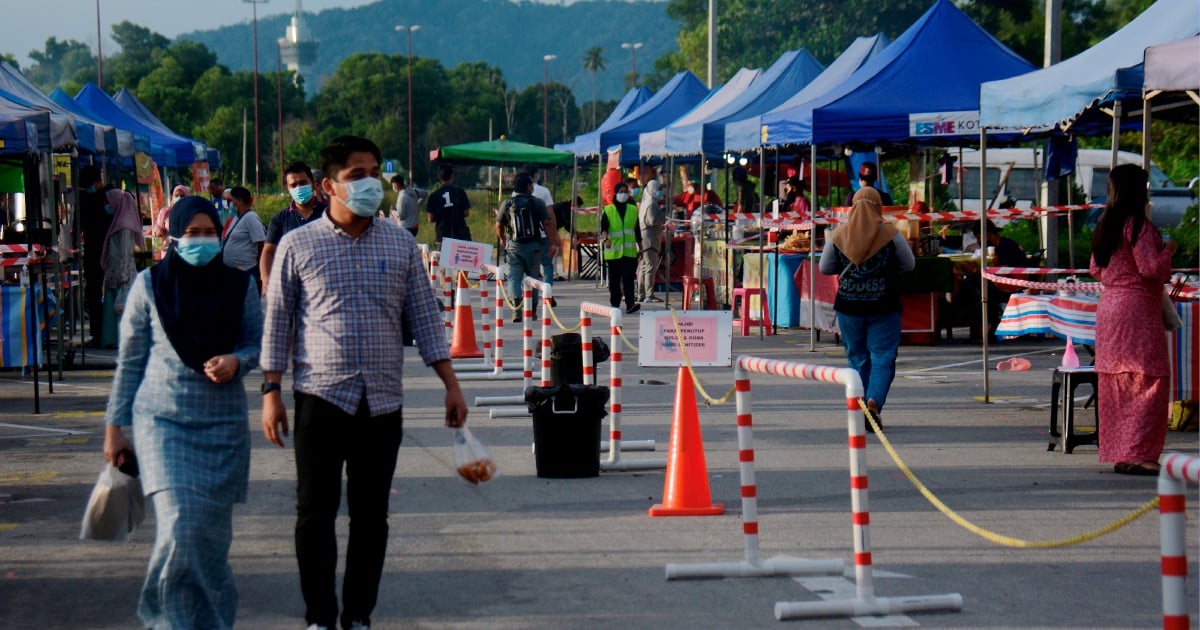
[262,136,467,629]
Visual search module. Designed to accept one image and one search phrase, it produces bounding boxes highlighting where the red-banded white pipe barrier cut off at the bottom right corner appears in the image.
[1158,452,1200,630]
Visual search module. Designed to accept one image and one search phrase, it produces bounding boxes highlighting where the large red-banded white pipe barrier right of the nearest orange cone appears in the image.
[667,356,962,620]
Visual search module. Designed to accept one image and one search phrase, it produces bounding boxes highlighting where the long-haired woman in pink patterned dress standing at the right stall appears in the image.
[1090,164,1177,476]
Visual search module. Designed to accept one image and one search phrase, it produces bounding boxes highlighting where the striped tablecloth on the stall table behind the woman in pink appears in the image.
[996,293,1200,401]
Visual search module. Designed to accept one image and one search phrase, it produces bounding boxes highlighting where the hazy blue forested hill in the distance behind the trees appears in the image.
[180,0,679,100]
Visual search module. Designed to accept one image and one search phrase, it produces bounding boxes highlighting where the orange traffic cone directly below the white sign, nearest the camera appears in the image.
[650,367,725,516]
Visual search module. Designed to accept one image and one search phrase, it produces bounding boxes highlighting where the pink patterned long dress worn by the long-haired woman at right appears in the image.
[1091,220,1171,462]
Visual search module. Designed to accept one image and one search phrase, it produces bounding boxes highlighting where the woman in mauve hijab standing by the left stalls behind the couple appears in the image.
[100,188,145,348]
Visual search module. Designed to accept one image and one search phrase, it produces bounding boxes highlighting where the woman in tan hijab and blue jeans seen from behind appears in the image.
[821,187,917,428]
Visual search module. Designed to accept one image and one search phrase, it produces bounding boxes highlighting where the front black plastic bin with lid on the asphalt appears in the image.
[526,385,608,479]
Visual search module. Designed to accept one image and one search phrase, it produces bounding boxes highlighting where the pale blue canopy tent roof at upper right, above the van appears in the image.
[979,0,1200,133]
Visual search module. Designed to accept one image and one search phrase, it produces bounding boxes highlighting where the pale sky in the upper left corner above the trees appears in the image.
[0,0,379,67]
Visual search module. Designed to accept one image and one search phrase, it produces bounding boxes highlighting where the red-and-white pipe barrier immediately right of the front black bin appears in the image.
[580,302,667,470]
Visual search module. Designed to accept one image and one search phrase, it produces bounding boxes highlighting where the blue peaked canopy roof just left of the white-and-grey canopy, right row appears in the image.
[556,71,708,156]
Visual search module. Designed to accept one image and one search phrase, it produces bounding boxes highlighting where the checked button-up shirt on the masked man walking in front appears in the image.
[260,212,450,415]
